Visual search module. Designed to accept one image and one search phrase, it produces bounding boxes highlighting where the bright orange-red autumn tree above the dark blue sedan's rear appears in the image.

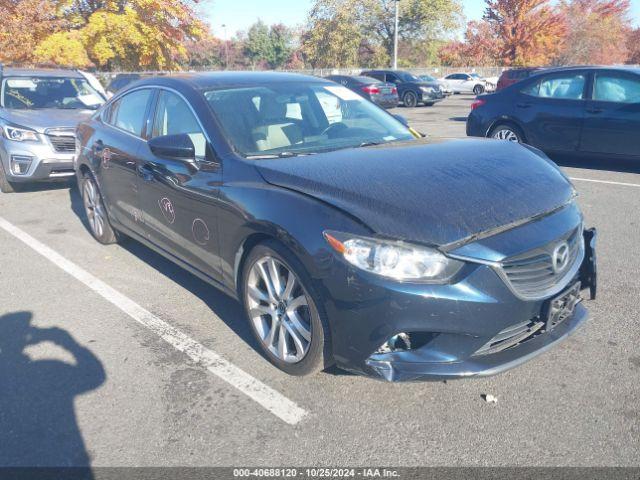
[484,0,566,66]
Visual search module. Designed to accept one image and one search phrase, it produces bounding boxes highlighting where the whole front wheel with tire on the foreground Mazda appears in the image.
[240,241,332,376]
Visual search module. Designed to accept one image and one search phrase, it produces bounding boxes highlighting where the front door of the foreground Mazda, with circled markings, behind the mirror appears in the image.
[138,90,222,279]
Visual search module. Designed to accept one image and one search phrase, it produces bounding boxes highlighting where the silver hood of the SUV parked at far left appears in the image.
[0,108,95,133]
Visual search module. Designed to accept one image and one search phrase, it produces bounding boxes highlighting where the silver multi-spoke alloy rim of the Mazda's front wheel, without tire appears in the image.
[245,256,312,363]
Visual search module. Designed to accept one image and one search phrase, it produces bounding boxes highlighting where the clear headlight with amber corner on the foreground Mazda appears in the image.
[324,231,464,283]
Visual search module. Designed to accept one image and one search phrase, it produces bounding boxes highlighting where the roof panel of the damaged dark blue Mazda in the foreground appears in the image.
[130,72,331,90]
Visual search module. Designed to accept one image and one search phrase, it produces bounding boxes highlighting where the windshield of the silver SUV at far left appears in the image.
[1,77,104,110]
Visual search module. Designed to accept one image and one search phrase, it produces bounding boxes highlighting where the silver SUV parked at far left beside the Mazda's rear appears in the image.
[0,67,105,193]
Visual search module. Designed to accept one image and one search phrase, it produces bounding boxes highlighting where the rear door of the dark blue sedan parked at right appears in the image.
[514,71,588,152]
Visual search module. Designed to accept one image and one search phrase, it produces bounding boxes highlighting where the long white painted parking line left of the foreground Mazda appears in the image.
[0,217,308,425]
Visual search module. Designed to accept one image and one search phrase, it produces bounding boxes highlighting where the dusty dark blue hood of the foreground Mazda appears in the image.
[257,139,573,246]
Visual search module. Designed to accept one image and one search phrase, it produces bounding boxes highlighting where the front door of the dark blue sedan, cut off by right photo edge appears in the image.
[580,70,640,156]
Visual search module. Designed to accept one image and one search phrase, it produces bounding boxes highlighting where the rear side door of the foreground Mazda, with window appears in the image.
[97,88,153,231]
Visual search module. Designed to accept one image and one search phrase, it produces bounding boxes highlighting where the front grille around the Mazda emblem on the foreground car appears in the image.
[499,228,584,299]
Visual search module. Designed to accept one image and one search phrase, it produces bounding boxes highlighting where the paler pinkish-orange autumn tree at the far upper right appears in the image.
[557,0,631,65]
